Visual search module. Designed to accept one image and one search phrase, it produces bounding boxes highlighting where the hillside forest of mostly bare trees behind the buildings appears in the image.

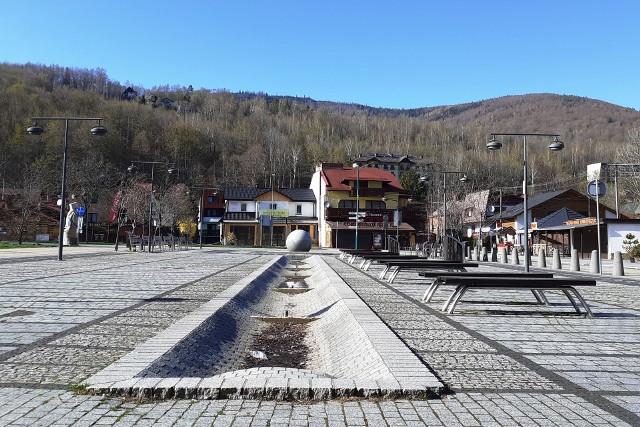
[0,63,640,241]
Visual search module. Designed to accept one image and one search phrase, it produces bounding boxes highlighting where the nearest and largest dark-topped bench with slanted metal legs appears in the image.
[438,276,596,317]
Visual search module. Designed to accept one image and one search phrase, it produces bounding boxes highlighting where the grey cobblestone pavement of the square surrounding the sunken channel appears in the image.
[0,246,640,426]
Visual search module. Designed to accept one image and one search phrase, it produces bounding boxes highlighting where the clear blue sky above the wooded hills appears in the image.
[0,0,640,110]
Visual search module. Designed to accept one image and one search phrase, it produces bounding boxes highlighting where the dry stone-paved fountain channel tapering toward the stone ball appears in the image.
[86,254,444,399]
